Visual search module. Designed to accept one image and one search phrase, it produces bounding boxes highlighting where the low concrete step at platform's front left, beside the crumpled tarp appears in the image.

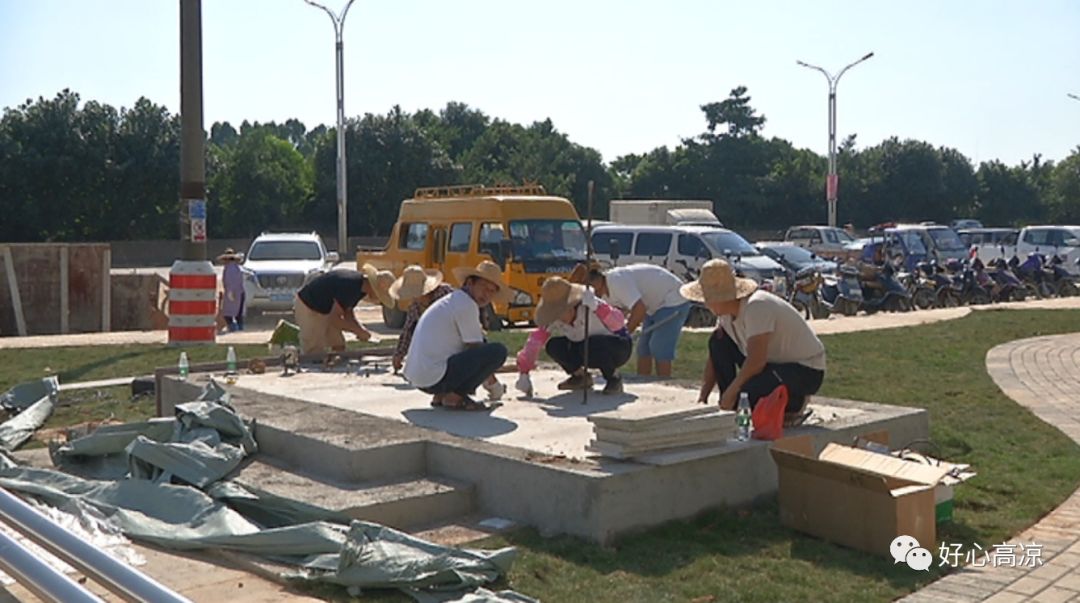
[234,455,474,530]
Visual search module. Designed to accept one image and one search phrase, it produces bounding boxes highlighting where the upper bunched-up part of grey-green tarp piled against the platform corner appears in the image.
[53,380,258,487]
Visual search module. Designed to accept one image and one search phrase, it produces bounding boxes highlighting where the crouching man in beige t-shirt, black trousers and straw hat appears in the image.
[681,259,825,416]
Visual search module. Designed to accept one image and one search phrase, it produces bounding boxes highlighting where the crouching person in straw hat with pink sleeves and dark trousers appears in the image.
[517,277,633,396]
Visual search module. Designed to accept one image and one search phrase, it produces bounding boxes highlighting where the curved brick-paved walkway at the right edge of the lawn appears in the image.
[904,333,1080,603]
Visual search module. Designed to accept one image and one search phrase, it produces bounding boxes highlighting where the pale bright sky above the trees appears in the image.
[0,0,1080,165]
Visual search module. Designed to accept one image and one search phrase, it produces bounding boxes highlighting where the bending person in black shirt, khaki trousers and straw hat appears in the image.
[293,264,394,353]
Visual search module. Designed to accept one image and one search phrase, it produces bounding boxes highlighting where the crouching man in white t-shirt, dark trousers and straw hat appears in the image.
[403,260,510,411]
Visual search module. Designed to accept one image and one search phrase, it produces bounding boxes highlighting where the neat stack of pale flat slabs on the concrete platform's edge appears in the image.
[586,404,735,459]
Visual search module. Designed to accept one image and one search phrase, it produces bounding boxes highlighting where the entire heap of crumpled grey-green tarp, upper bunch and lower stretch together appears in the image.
[0,381,534,603]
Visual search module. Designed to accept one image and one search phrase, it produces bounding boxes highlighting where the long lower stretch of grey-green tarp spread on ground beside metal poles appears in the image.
[0,467,516,590]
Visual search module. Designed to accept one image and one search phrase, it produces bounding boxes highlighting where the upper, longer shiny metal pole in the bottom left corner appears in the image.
[0,487,190,603]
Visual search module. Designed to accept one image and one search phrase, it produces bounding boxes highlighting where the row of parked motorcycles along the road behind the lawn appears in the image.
[778,253,1080,319]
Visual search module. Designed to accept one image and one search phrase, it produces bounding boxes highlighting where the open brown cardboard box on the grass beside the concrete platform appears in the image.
[771,436,949,557]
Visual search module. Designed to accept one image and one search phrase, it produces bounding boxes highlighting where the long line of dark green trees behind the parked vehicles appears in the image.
[0,88,1080,241]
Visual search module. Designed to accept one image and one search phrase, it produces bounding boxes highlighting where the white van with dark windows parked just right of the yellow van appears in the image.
[592,225,784,286]
